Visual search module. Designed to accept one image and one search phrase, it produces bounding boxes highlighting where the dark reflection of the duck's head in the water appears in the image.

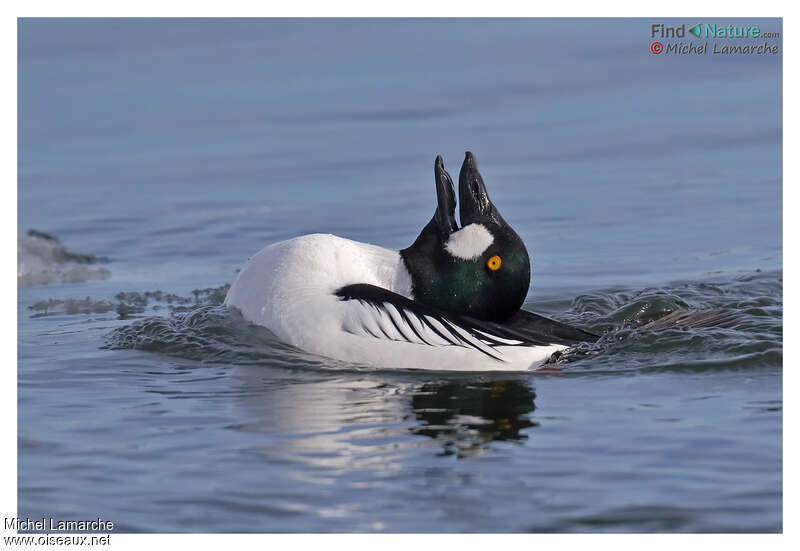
[411,380,538,457]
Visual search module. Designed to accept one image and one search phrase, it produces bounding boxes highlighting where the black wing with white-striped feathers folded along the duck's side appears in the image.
[334,283,598,360]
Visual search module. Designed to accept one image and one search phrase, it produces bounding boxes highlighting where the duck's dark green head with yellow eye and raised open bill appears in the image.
[400,151,531,321]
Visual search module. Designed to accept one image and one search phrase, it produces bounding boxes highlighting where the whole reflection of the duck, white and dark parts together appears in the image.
[231,367,537,469]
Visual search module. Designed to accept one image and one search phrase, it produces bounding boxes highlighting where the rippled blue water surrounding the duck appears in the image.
[18,19,783,532]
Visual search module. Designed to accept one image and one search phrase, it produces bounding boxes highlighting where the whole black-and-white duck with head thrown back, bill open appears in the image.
[224,151,599,371]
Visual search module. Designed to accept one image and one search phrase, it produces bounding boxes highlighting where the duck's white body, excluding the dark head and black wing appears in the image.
[225,234,567,371]
